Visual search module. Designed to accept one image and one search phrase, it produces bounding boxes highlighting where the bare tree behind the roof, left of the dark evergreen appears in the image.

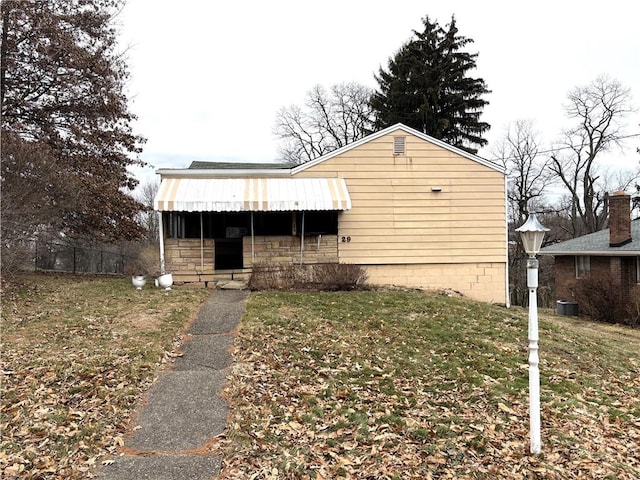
[273,82,373,164]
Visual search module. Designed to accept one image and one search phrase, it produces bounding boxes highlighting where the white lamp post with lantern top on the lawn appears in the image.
[516,213,549,453]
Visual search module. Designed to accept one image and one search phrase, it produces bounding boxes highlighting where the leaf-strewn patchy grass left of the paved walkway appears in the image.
[0,275,208,479]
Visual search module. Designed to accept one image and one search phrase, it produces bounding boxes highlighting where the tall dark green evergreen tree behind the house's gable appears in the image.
[371,17,490,153]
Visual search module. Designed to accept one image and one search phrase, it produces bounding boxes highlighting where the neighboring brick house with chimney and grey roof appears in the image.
[540,192,640,312]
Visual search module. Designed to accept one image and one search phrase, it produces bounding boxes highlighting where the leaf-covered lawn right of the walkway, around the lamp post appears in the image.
[220,292,640,479]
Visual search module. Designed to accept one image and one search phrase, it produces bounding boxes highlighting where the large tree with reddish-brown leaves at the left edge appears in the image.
[0,0,144,245]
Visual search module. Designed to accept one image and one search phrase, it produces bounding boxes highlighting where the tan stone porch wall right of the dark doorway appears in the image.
[242,235,338,268]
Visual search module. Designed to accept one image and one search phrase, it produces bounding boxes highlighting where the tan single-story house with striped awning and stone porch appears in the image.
[154,124,508,303]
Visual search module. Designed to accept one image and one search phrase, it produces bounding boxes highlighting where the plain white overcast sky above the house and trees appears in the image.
[119,0,640,184]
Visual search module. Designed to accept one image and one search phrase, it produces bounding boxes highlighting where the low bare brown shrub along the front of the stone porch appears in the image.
[249,263,367,291]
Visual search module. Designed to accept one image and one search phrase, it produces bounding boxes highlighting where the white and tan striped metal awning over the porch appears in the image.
[153,178,351,212]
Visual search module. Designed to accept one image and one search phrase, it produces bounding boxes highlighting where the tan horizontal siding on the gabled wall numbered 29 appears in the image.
[296,133,506,270]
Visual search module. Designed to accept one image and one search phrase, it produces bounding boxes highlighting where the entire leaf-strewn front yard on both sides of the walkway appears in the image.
[0,276,640,479]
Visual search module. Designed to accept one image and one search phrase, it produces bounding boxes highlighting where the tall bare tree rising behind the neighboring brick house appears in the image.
[549,76,633,237]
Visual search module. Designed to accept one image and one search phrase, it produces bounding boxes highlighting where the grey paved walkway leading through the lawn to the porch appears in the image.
[97,290,248,480]
